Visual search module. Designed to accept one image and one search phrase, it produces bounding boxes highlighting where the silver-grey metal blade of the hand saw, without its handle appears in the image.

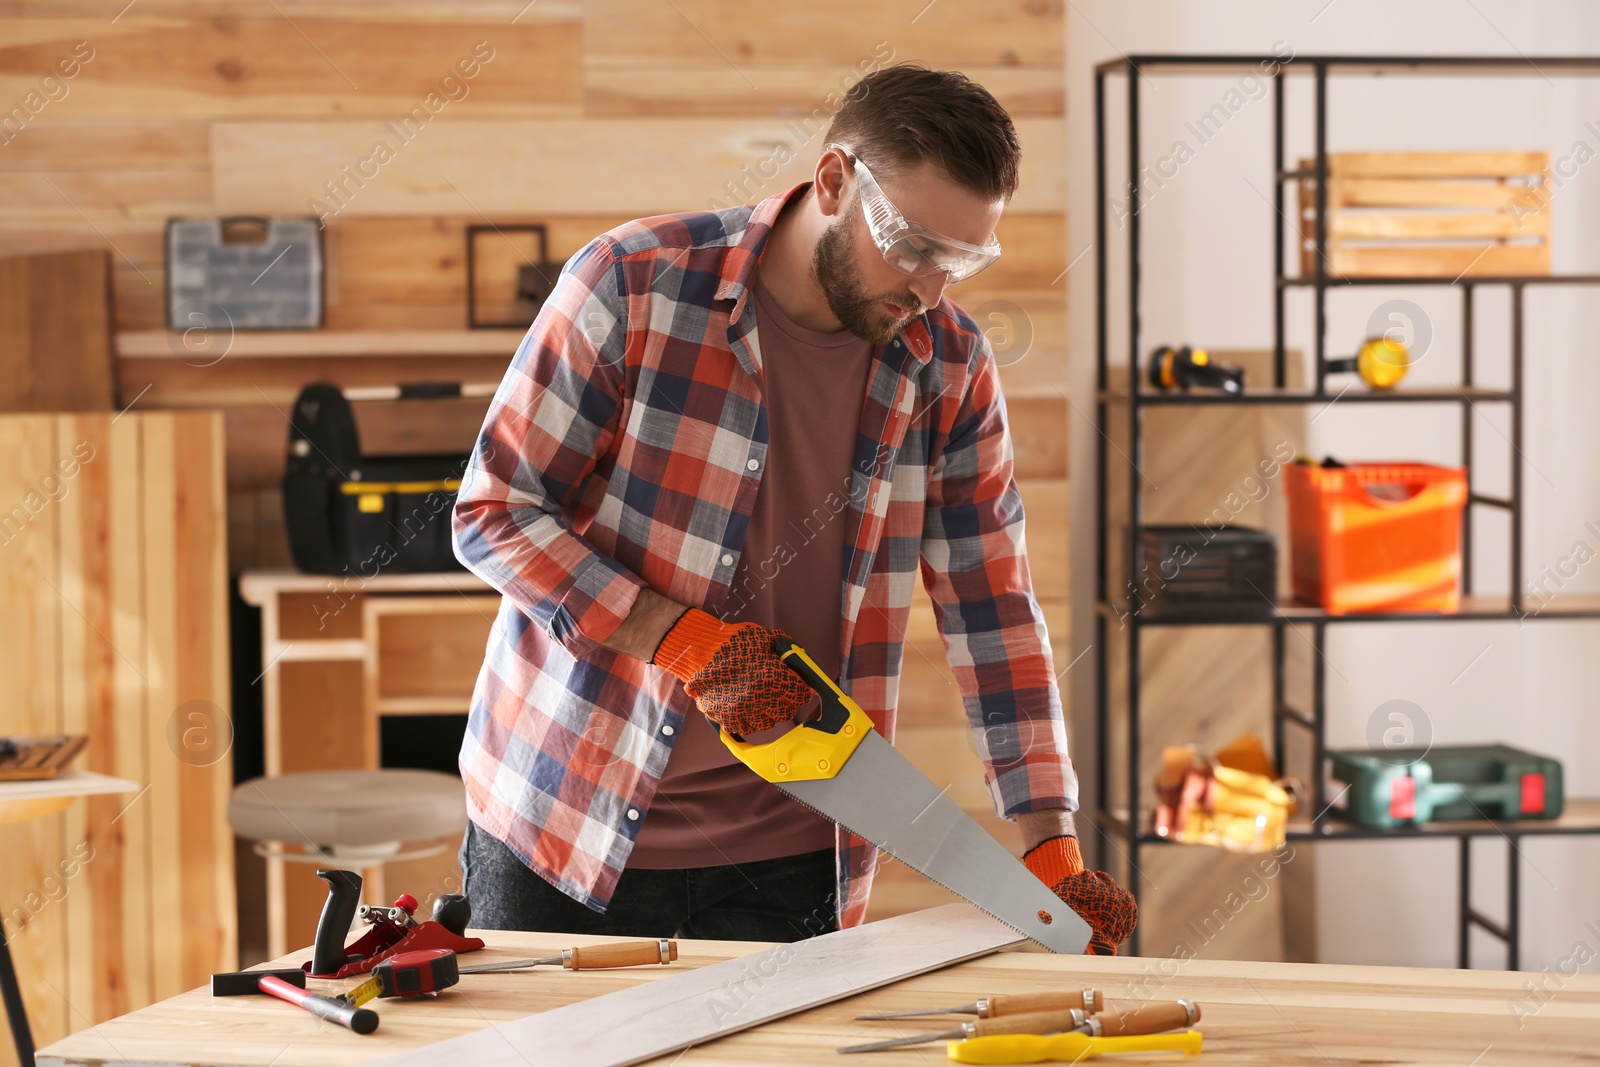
[778,729,1091,953]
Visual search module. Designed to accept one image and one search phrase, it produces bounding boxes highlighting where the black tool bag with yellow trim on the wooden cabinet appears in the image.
[283,382,494,577]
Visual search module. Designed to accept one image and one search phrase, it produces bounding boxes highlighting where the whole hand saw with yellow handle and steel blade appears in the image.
[722,637,1090,953]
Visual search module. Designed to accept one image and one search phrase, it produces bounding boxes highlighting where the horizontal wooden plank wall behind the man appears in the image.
[0,0,1088,913]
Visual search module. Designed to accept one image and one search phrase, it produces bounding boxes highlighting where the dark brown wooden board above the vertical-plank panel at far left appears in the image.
[0,251,114,411]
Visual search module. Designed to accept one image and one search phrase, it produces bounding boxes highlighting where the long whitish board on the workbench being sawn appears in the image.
[373,904,1027,1067]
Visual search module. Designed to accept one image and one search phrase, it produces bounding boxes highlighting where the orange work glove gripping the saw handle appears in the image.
[650,608,811,736]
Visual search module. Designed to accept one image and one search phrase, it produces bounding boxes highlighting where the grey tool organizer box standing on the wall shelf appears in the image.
[166,218,323,330]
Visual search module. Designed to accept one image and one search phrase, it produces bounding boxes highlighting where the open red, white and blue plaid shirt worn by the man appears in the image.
[453,186,1077,926]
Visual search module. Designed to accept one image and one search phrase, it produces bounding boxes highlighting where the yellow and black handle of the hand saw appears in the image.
[718,637,872,782]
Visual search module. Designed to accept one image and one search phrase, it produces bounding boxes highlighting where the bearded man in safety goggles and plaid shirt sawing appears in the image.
[454,66,1136,953]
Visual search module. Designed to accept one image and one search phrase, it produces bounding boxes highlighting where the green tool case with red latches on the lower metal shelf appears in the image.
[1328,745,1563,830]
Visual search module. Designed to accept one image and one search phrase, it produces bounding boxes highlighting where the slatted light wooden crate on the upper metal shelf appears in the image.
[1299,152,1550,278]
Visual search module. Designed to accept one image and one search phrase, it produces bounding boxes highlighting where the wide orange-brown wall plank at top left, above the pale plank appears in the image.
[0,10,582,119]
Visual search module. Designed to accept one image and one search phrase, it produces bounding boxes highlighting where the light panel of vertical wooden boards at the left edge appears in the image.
[0,413,237,1067]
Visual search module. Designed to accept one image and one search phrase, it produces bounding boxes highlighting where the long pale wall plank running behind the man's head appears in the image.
[209,118,1066,218]
